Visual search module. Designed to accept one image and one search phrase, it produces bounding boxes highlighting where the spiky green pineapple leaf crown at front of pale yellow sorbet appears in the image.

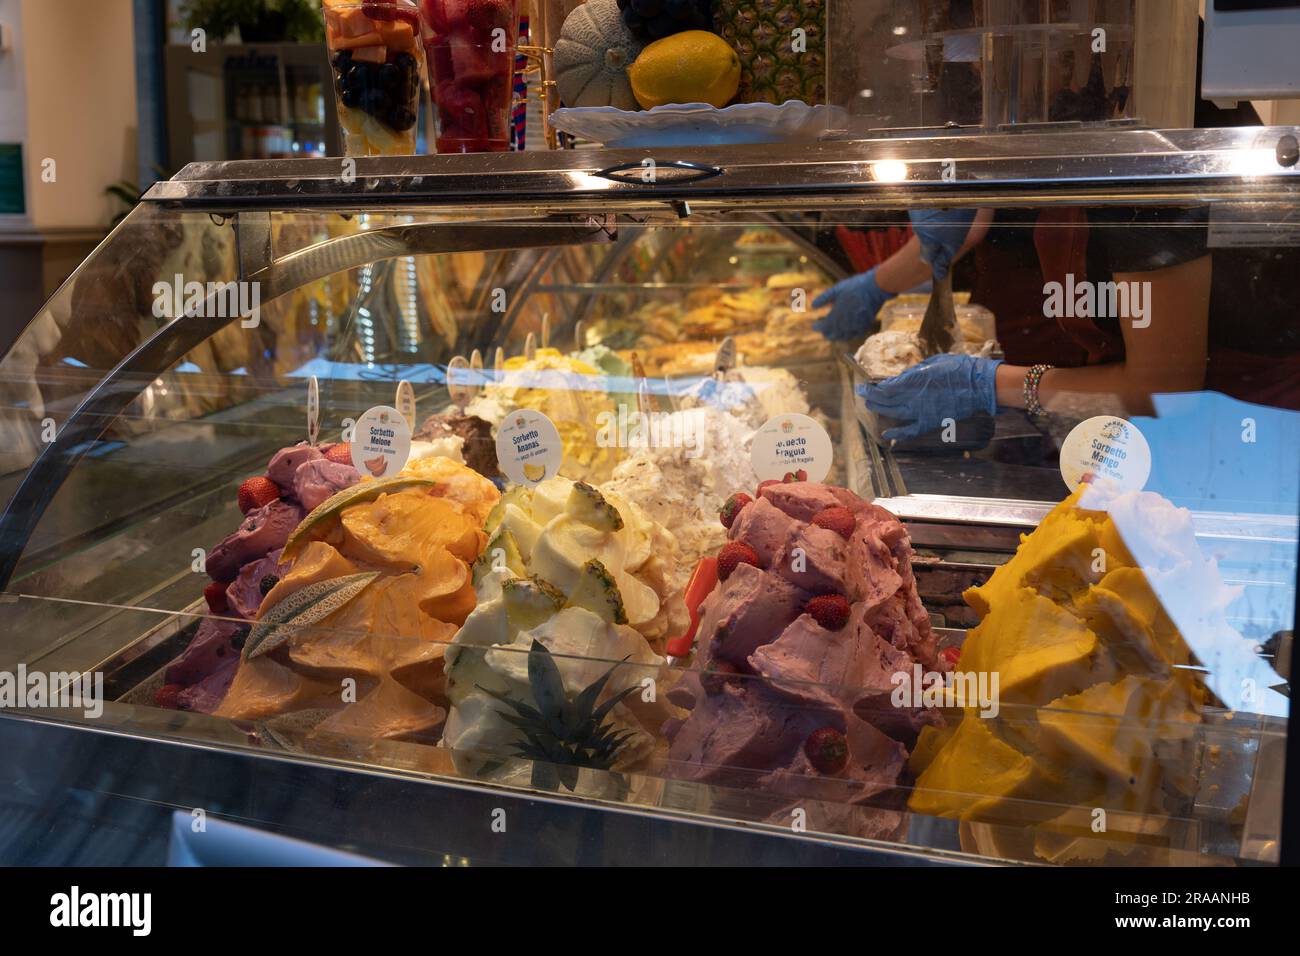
[478,640,636,791]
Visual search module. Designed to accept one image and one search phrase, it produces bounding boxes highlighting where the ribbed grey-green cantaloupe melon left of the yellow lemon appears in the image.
[554,0,642,109]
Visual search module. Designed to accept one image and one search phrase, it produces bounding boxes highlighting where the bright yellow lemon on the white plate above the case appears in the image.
[628,30,740,109]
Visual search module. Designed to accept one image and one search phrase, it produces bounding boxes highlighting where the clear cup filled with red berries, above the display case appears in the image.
[420,0,519,153]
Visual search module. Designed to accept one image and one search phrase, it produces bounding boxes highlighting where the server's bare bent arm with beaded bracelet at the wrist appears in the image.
[997,256,1210,416]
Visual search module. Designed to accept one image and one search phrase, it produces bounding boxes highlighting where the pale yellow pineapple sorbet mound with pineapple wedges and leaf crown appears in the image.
[442,477,680,782]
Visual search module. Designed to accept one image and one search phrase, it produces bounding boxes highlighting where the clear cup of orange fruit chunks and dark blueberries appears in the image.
[324,0,424,156]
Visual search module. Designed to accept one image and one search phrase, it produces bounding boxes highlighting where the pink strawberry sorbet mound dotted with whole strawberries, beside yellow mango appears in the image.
[668,481,948,838]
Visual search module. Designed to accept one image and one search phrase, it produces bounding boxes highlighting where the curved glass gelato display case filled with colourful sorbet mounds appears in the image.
[0,127,1300,866]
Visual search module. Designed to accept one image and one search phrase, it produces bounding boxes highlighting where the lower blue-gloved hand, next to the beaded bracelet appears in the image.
[858,355,1002,441]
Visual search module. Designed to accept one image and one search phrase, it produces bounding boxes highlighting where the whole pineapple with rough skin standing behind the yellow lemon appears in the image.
[714,0,827,104]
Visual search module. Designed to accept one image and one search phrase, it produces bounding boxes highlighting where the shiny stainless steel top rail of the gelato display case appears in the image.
[144,126,1300,211]
